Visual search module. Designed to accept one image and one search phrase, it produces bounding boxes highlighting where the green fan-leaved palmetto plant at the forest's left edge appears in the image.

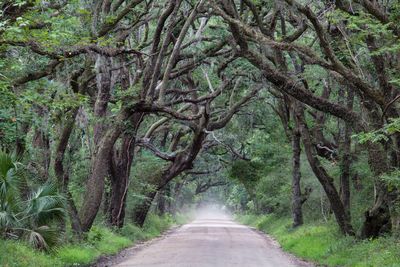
[0,151,65,249]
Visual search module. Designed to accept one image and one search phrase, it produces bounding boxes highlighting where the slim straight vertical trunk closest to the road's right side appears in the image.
[292,127,303,227]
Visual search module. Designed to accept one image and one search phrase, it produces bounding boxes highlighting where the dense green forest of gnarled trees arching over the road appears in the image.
[0,0,400,266]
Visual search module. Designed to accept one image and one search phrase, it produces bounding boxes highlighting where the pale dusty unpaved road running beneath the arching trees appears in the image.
[114,213,312,267]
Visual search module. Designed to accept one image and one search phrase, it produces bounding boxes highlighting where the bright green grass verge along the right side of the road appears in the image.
[238,215,400,267]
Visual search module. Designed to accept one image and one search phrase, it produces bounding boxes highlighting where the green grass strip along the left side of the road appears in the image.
[0,214,188,267]
